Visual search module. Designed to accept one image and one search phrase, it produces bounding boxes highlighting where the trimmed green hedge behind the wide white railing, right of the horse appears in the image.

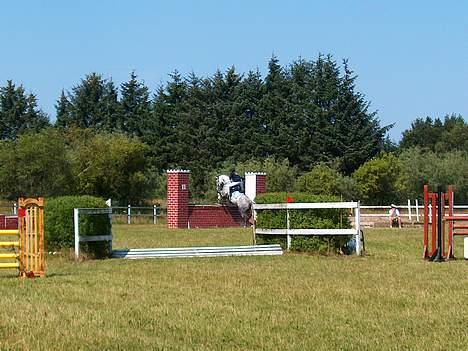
[255,193,352,254]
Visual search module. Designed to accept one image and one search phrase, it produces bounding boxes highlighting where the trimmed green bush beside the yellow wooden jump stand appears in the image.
[44,196,111,257]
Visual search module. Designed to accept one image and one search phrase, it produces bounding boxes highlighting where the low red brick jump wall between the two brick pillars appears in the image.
[188,205,243,228]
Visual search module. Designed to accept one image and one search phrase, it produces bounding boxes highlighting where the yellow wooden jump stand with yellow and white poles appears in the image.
[0,197,45,278]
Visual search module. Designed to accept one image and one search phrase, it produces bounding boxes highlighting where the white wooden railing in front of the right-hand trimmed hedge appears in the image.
[253,202,361,255]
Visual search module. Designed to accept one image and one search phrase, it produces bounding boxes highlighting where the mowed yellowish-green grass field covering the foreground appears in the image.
[0,225,468,350]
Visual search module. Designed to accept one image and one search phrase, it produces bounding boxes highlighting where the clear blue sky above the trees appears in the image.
[0,0,468,140]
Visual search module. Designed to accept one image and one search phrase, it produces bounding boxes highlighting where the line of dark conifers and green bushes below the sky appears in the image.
[0,55,468,202]
